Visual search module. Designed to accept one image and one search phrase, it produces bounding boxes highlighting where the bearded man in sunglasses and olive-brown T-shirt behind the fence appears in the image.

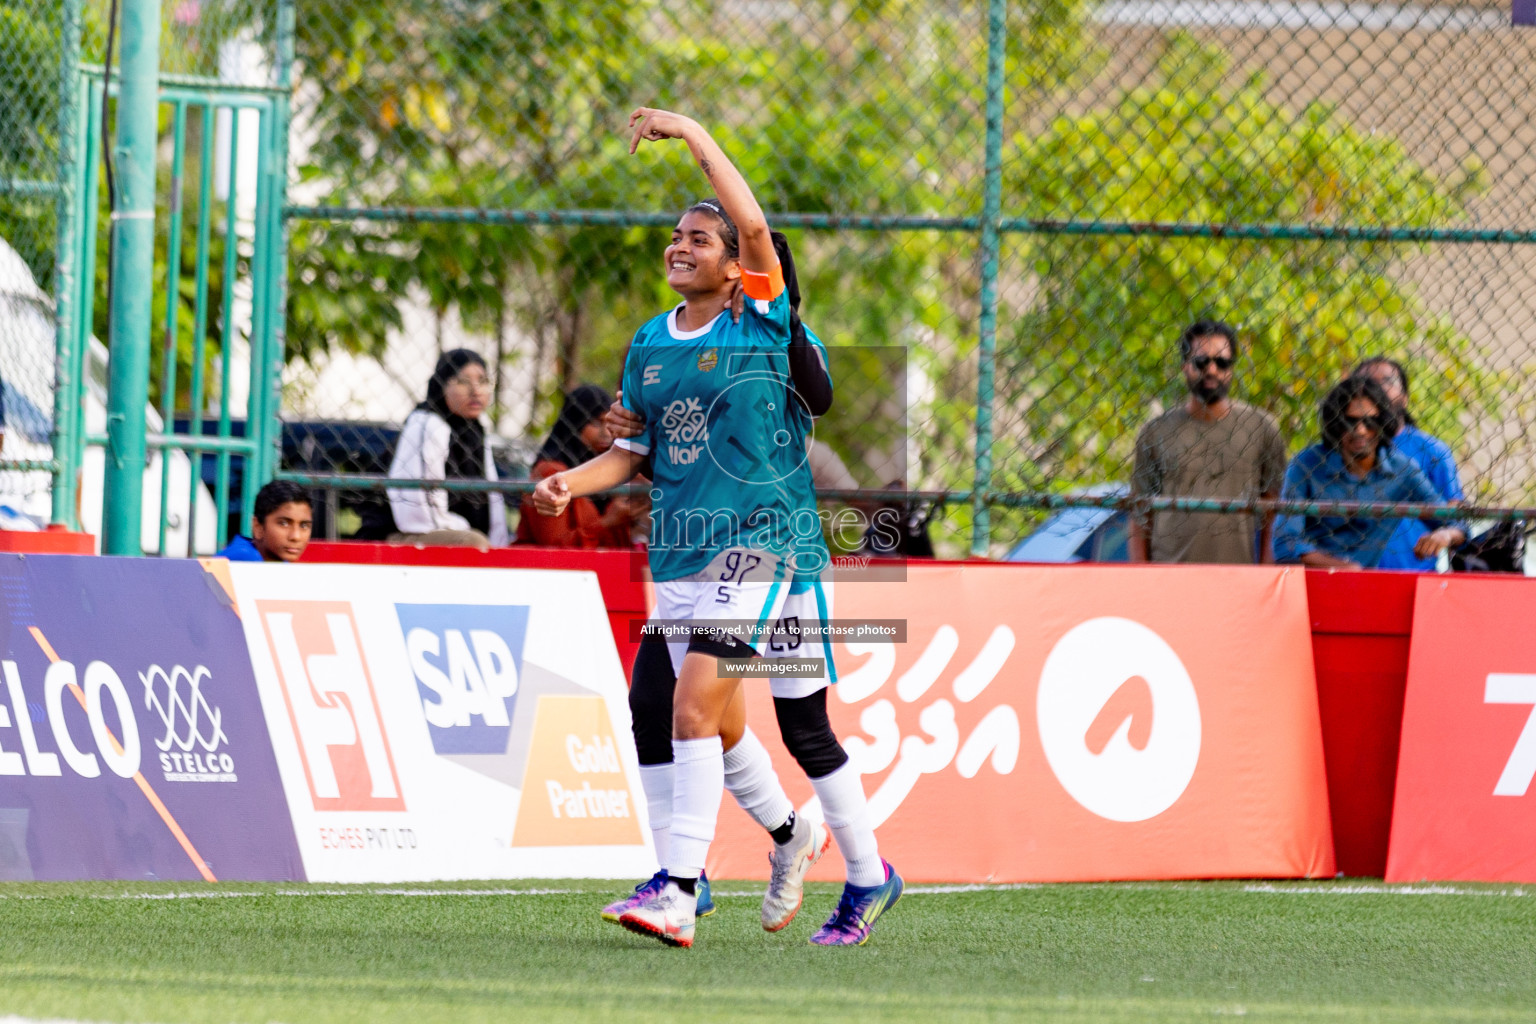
[1129,319,1286,563]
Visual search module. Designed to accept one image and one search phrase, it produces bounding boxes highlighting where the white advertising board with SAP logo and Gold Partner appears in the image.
[229,563,653,881]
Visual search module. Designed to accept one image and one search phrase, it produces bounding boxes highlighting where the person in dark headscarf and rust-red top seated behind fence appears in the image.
[518,384,648,548]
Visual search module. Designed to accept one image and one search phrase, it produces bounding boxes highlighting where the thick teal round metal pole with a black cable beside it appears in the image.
[101,0,160,554]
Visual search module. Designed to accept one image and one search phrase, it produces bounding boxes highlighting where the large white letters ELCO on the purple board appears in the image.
[0,660,143,778]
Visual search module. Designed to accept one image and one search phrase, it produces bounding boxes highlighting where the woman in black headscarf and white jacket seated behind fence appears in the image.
[389,348,507,551]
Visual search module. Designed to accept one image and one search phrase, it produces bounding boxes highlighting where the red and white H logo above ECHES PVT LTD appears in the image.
[257,600,406,811]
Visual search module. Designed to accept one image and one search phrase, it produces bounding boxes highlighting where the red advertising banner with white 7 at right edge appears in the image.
[1387,576,1536,881]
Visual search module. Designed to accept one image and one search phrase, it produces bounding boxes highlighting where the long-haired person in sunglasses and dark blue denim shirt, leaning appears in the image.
[1275,376,1467,568]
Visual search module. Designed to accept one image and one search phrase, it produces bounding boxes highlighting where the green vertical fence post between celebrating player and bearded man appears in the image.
[971,0,1008,559]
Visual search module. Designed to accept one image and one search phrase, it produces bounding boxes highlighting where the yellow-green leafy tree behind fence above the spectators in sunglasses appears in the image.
[997,35,1493,509]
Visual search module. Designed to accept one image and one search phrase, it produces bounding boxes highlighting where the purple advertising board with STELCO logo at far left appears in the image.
[0,554,304,881]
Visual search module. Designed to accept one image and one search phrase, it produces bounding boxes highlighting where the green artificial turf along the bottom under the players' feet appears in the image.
[0,881,1536,1024]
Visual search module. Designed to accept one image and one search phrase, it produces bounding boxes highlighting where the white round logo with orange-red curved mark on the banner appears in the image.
[1035,617,1200,821]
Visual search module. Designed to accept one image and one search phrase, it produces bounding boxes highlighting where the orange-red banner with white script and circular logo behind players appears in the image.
[710,565,1333,881]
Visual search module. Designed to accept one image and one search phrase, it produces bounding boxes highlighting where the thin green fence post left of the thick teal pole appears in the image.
[49,0,86,528]
